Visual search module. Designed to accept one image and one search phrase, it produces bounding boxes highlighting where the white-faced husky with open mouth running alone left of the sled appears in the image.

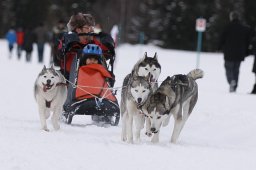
[34,66,67,131]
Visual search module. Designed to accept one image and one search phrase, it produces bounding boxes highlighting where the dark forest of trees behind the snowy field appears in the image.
[0,0,256,51]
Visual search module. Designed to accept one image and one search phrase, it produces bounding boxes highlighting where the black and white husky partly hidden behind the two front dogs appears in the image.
[125,52,161,91]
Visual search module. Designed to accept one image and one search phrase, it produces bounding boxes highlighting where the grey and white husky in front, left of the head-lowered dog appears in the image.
[121,74,153,143]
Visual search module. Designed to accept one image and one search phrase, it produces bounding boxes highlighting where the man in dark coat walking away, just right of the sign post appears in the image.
[219,12,251,92]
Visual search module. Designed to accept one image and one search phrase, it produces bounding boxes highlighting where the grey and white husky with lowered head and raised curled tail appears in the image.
[143,69,204,143]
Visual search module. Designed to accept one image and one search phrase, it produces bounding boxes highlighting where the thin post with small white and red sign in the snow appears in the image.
[196,18,206,68]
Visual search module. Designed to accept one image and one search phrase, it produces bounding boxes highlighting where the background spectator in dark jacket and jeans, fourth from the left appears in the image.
[35,23,48,63]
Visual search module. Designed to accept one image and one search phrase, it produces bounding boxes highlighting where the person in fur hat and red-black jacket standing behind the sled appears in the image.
[55,13,115,86]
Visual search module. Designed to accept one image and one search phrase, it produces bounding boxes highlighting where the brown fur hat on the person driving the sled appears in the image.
[67,13,95,31]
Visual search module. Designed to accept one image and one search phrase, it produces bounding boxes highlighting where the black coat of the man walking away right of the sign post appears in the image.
[220,20,251,61]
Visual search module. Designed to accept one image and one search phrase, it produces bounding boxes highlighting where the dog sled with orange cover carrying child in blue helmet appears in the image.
[60,32,120,126]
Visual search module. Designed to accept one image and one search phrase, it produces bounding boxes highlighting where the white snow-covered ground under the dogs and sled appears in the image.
[0,40,256,170]
